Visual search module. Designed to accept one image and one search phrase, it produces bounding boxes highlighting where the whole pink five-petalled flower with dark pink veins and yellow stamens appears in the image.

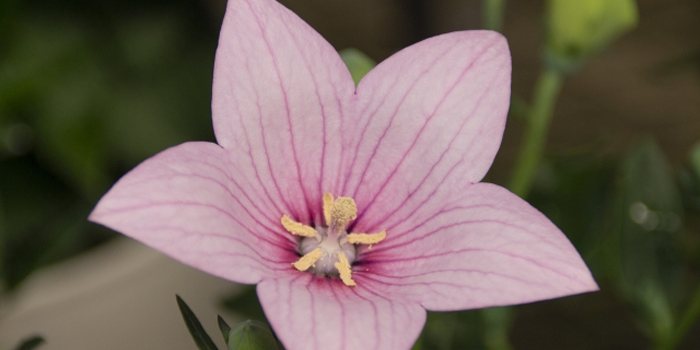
[90,0,597,350]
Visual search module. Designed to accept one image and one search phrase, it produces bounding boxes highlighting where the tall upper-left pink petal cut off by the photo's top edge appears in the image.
[212,0,354,223]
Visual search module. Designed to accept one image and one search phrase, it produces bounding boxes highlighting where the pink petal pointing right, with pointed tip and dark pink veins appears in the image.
[356,183,598,311]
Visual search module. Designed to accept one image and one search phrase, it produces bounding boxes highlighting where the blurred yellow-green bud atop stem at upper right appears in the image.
[547,0,638,67]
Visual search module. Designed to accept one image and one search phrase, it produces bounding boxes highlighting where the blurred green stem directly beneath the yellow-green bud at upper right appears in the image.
[509,68,564,198]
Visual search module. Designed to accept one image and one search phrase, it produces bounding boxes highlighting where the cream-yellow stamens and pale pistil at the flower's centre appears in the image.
[281,193,386,287]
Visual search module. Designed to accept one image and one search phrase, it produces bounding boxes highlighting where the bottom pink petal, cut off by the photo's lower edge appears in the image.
[258,274,426,350]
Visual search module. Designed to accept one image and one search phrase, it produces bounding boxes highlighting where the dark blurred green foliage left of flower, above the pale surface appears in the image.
[0,0,218,291]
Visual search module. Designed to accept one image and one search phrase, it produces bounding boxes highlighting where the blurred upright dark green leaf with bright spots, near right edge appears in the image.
[606,140,685,341]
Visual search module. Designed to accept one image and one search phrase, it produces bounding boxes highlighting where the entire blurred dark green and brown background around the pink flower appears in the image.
[0,0,700,350]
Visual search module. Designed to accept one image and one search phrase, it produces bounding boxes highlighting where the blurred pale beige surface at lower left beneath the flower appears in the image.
[0,238,241,350]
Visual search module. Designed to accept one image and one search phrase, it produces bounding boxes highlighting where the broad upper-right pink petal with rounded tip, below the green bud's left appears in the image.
[342,31,511,232]
